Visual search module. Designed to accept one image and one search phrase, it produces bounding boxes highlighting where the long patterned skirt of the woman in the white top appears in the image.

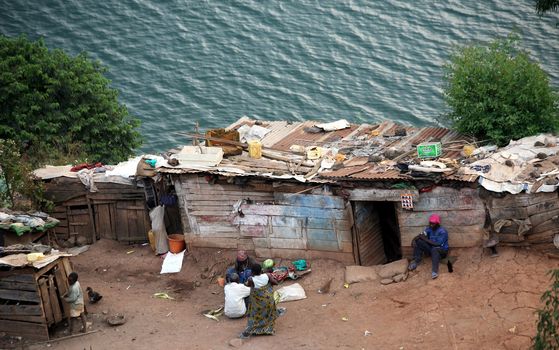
[243,284,277,336]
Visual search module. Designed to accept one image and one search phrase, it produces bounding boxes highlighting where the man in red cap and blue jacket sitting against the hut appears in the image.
[408,214,448,279]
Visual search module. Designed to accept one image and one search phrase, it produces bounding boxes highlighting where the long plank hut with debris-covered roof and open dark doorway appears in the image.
[158,118,559,265]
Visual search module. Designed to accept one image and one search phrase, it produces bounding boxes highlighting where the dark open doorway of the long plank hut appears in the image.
[353,202,402,265]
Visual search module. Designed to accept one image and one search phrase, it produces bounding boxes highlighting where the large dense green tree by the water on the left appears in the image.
[0,35,141,166]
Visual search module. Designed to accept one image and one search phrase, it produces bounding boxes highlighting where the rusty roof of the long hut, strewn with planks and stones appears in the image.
[159,117,477,182]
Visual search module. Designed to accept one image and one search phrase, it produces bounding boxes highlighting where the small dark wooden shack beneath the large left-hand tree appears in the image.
[35,166,154,246]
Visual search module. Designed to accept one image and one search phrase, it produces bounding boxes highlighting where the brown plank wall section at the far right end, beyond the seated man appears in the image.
[486,192,559,252]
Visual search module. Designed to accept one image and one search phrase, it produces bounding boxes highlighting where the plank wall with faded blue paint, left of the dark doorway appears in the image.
[175,175,353,262]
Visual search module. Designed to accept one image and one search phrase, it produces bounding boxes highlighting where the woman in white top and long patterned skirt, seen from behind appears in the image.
[240,264,278,339]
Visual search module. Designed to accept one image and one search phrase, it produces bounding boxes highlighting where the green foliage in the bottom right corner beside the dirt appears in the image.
[532,270,559,350]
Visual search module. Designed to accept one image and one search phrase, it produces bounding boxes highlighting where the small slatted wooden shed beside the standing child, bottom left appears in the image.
[0,254,72,341]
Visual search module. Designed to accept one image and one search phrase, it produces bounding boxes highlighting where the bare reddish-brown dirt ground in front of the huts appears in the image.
[12,240,559,350]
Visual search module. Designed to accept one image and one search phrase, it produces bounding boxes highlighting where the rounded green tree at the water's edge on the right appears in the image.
[444,35,559,146]
